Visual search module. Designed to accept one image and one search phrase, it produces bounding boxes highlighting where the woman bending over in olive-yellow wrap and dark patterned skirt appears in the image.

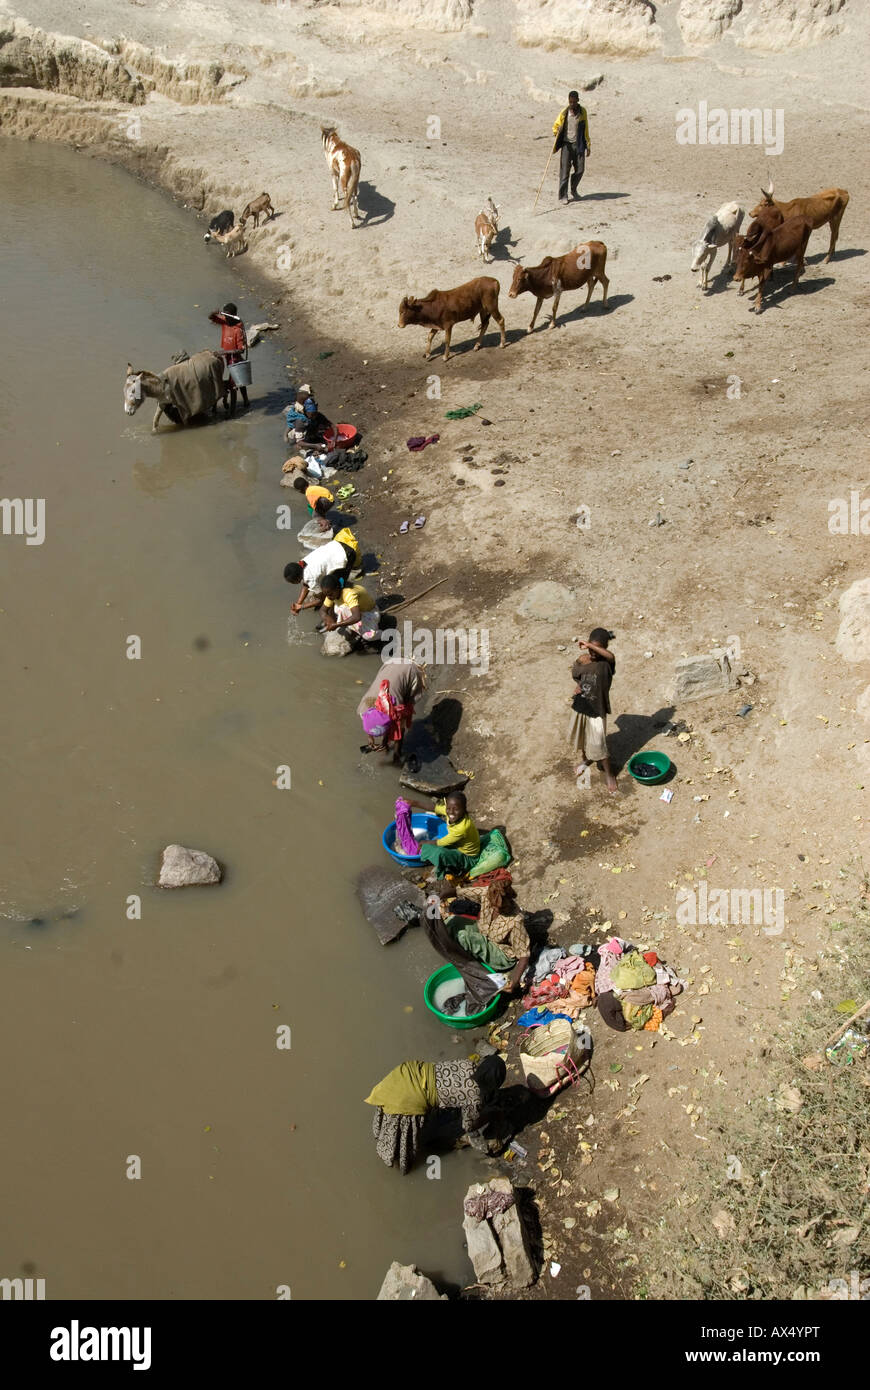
[366,1056,507,1173]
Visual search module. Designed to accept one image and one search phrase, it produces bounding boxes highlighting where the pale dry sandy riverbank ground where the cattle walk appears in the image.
[0,0,870,1298]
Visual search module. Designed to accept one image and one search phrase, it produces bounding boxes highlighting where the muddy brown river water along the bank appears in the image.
[0,142,486,1300]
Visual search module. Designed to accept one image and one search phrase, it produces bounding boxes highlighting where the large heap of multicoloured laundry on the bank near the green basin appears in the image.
[517,937,685,1033]
